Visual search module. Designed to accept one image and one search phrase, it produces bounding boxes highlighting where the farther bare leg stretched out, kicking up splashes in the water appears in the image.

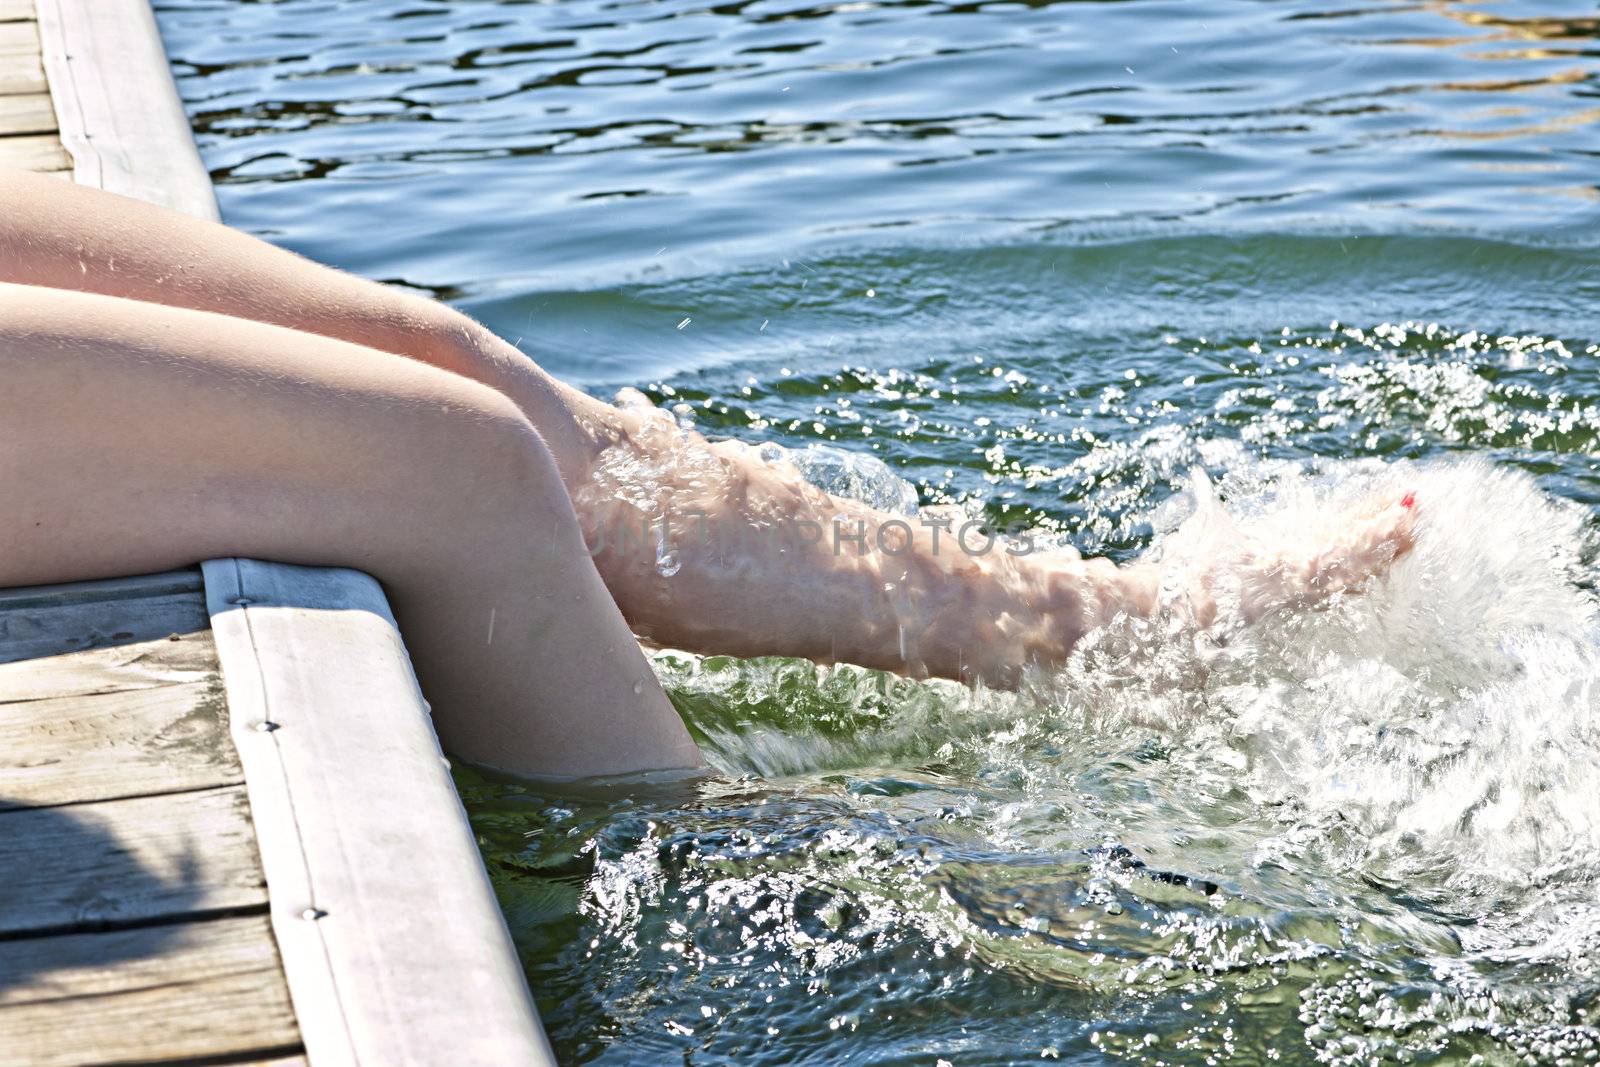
[0,173,1410,683]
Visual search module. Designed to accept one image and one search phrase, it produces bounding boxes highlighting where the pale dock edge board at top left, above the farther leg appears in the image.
[35,0,221,219]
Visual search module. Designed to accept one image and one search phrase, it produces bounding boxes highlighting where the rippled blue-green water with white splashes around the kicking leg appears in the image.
[160,0,1600,1067]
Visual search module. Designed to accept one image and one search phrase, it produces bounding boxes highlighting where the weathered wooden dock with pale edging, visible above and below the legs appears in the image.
[0,0,552,1067]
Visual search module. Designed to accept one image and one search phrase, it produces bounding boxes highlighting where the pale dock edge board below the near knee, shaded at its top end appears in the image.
[202,560,554,1067]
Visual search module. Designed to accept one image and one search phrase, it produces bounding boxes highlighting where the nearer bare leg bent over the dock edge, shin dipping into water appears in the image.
[0,283,698,774]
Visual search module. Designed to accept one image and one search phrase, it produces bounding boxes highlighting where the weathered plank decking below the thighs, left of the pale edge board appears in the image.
[0,571,306,1067]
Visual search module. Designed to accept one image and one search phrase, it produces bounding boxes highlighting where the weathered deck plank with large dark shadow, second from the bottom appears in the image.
[0,785,267,934]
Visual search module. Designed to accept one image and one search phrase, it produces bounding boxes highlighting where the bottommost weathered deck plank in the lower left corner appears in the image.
[0,915,302,1067]
